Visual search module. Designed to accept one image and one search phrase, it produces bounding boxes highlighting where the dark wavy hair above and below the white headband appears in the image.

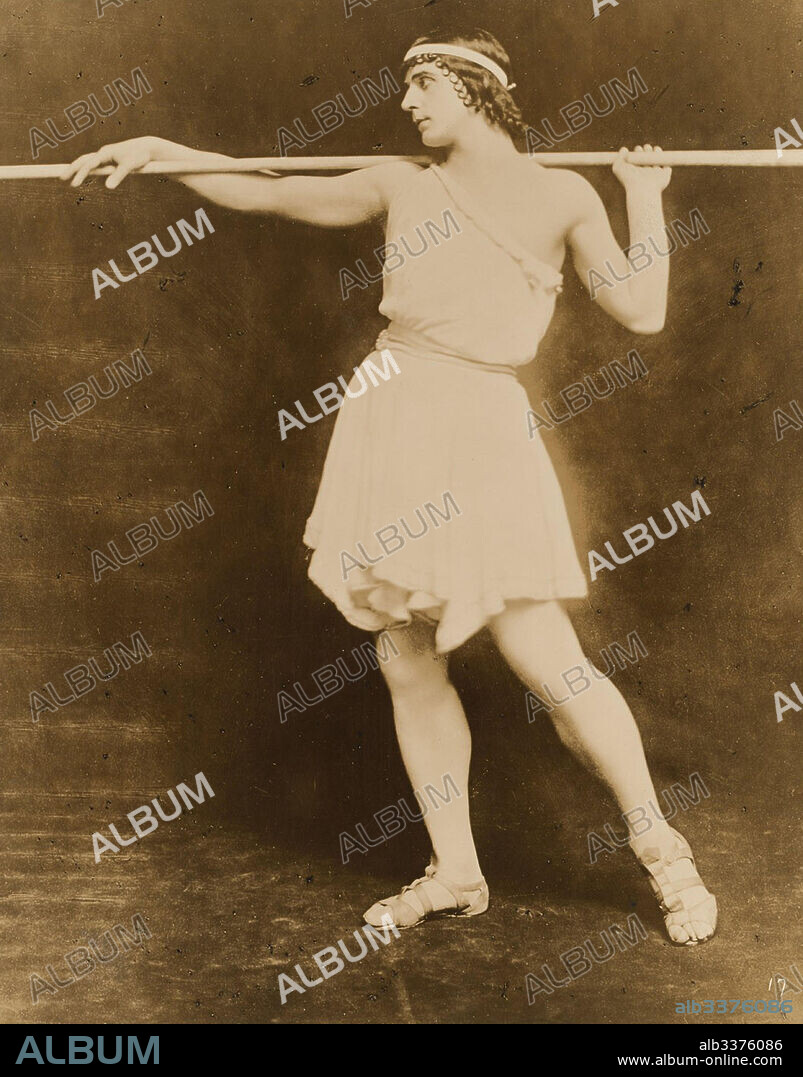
[402,27,525,138]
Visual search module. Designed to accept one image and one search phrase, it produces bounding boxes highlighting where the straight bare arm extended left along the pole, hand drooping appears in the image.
[62,137,418,228]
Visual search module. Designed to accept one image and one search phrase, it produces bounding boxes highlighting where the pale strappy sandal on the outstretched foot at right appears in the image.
[637,827,717,946]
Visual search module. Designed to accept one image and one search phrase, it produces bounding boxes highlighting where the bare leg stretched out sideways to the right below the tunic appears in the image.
[491,600,713,942]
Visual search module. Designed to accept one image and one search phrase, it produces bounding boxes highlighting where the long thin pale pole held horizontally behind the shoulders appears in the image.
[0,150,803,180]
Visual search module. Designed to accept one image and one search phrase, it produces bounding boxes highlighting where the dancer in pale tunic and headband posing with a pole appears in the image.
[64,30,717,946]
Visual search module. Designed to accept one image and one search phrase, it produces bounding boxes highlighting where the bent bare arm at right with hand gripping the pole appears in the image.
[568,145,672,333]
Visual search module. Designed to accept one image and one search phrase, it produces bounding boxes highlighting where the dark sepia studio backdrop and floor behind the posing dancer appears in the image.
[0,0,803,1023]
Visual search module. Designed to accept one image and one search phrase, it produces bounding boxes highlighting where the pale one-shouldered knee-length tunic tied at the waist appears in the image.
[304,165,587,653]
